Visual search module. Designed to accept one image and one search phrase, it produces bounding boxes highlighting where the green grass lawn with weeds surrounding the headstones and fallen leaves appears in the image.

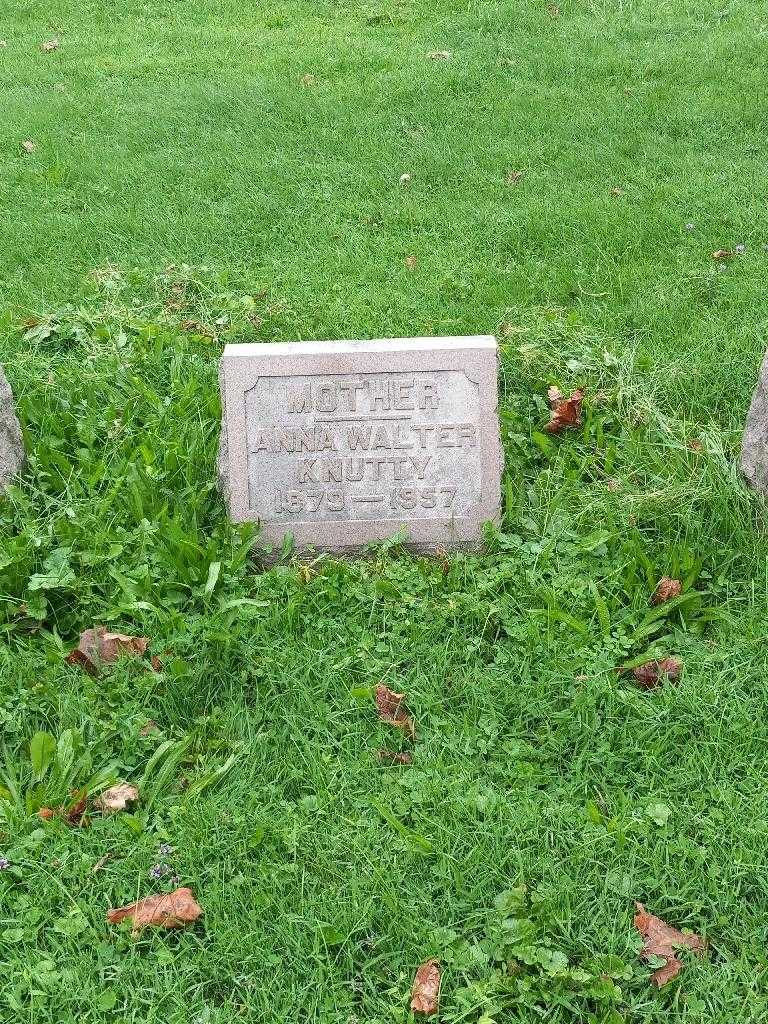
[0,0,768,1024]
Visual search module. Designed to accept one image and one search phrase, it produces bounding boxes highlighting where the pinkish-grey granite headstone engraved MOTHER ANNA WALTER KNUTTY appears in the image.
[218,336,501,552]
